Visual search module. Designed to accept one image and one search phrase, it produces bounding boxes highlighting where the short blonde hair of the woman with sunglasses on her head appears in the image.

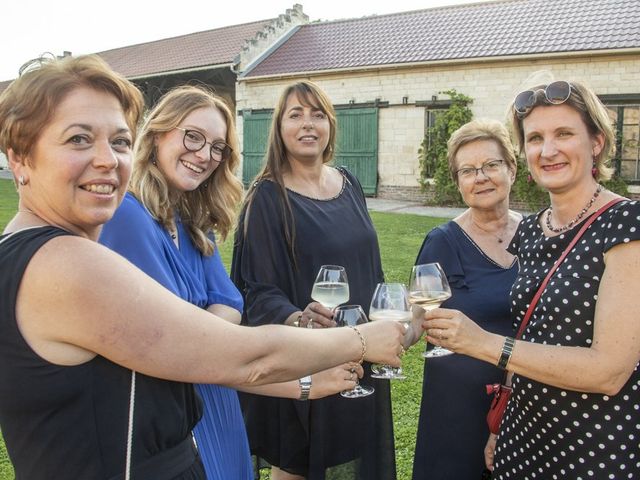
[508,82,616,181]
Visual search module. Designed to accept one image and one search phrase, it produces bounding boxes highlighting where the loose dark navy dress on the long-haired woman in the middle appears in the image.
[232,170,395,480]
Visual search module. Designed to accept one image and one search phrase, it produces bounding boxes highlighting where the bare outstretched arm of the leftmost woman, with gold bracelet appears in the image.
[16,236,403,386]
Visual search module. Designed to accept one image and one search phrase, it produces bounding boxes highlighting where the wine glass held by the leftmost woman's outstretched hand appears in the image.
[369,283,411,380]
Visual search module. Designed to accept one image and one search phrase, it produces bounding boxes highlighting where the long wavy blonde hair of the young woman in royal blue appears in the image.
[129,85,242,255]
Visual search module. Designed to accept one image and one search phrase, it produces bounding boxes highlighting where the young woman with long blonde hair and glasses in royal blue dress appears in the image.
[100,86,359,480]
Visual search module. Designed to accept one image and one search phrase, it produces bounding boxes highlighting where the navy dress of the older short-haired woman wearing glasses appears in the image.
[413,221,518,480]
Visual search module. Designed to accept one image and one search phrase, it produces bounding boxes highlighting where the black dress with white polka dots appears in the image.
[492,201,640,479]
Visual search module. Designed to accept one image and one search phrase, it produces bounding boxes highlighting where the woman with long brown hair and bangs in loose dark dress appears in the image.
[232,82,395,480]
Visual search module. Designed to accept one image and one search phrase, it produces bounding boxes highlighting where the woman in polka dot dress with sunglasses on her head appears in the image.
[424,81,640,480]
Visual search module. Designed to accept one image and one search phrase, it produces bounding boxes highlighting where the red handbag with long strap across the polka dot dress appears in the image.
[487,198,624,434]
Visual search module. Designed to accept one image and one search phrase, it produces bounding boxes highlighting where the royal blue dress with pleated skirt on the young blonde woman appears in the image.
[100,193,253,480]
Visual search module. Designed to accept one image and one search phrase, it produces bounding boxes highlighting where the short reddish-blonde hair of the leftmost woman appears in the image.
[0,55,144,157]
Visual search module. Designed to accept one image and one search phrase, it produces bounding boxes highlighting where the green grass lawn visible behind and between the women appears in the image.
[0,180,446,480]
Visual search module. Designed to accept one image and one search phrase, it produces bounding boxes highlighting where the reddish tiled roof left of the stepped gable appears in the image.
[98,19,272,78]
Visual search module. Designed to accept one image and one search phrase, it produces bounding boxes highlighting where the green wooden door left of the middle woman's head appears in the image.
[242,111,271,187]
